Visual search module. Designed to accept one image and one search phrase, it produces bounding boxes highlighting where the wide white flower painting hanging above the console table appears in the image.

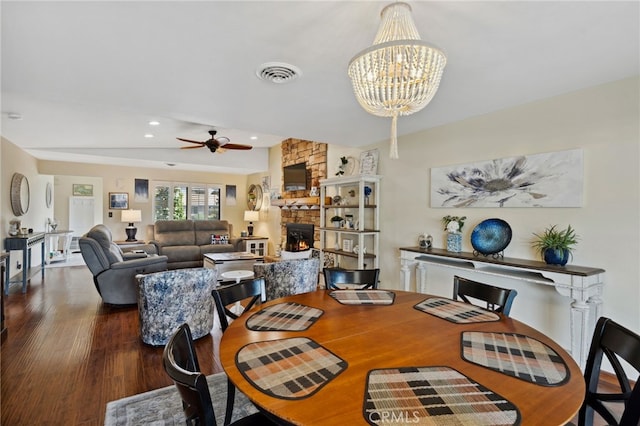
[431,149,583,207]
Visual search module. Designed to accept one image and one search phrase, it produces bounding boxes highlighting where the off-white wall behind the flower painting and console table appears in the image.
[378,77,640,347]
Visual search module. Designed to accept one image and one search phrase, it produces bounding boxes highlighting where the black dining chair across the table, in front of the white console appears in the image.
[453,275,518,316]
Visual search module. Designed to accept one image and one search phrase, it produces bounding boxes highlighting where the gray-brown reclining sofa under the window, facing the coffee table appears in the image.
[150,220,244,269]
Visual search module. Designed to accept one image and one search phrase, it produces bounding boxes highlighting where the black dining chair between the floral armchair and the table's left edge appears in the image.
[211,278,265,424]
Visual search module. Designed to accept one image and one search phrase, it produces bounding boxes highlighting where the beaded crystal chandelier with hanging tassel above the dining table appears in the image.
[349,2,447,158]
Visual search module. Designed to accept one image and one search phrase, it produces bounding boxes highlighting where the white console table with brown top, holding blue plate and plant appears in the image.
[400,247,605,368]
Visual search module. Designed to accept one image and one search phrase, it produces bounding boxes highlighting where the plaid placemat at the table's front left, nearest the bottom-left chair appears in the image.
[236,337,347,399]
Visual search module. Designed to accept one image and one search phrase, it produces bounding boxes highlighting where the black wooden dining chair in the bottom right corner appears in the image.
[578,317,640,426]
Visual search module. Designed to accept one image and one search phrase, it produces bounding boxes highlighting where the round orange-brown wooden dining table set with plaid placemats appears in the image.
[220,290,585,425]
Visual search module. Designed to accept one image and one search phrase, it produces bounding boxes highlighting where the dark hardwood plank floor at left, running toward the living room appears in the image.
[0,266,620,426]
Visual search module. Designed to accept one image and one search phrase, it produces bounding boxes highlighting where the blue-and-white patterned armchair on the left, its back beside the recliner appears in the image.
[136,268,218,346]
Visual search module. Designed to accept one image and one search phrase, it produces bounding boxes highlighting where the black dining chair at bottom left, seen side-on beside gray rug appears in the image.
[162,323,271,426]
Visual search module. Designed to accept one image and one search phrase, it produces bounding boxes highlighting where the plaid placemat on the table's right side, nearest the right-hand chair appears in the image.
[462,331,570,386]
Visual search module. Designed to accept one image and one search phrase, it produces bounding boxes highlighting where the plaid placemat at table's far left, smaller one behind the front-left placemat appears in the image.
[246,303,324,331]
